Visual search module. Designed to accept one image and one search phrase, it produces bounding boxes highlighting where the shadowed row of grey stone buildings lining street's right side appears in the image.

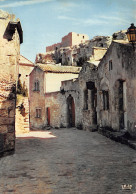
[61,40,136,136]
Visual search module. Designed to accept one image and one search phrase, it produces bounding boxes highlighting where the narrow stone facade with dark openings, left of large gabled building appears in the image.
[79,63,97,131]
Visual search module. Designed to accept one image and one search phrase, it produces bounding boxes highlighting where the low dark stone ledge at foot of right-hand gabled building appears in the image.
[98,128,136,150]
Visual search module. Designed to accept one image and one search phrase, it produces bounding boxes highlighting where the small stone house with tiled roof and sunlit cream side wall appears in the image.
[29,64,81,129]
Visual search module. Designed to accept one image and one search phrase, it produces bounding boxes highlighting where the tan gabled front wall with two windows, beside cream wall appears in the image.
[29,68,46,130]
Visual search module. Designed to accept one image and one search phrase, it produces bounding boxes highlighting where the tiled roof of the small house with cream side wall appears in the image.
[36,63,81,74]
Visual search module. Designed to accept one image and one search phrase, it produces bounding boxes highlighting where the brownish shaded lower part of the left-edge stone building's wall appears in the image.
[0,81,16,156]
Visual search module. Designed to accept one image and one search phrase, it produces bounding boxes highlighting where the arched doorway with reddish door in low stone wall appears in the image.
[67,95,75,127]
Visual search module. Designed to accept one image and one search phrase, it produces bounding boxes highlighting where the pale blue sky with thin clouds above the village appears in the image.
[0,0,136,62]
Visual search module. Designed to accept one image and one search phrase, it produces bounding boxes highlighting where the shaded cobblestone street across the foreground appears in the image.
[0,129,136,194]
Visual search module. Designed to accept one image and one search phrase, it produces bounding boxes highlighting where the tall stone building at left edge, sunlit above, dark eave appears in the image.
[0,10,23,155]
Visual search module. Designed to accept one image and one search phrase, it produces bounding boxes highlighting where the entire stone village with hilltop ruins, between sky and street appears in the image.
[0,11,136,157]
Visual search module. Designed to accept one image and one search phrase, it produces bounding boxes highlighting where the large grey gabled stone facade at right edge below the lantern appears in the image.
[97,42,136,135]
